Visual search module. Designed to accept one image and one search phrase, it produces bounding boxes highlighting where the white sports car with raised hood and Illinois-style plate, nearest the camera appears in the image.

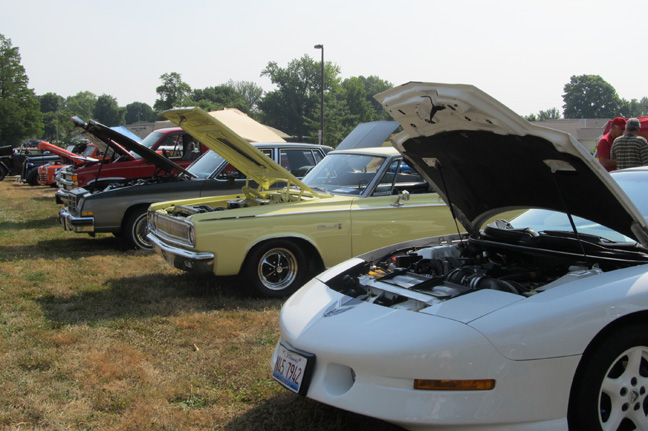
[272,83,648,431]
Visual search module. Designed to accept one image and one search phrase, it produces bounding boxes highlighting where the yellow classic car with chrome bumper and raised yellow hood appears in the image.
[148,108,457,297]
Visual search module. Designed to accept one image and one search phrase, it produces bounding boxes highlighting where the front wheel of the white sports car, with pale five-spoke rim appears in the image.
[568,325,648,431]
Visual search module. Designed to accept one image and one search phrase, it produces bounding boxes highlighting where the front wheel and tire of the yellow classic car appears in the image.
[242,240,310,298]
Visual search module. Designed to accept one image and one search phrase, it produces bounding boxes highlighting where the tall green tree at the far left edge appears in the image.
[0,34,43,146]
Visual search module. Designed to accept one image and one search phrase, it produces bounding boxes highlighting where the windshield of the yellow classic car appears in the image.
[303,153,385,195]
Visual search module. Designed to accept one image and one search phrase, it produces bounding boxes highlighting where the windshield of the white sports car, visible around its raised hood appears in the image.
[510,171,648,242]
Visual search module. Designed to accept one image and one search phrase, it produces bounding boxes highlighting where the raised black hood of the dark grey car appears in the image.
[72,117,195,177]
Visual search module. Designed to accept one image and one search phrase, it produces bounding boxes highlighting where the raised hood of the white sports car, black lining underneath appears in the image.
[376,82,648,246]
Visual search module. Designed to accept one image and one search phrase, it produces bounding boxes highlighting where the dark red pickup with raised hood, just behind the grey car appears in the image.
[56,117,207,203]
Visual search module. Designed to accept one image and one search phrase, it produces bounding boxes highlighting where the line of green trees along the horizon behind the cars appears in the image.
[0,34,648,147]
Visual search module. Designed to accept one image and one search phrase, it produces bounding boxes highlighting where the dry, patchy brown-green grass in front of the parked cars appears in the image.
[0,179,400,431]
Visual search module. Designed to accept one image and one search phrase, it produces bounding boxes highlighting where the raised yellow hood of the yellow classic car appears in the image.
[162,108,317,195]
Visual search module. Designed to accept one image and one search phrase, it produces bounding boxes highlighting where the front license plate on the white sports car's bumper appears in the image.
[272,344,315,395]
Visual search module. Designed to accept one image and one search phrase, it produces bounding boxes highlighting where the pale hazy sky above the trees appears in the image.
[0,0,648,115]
